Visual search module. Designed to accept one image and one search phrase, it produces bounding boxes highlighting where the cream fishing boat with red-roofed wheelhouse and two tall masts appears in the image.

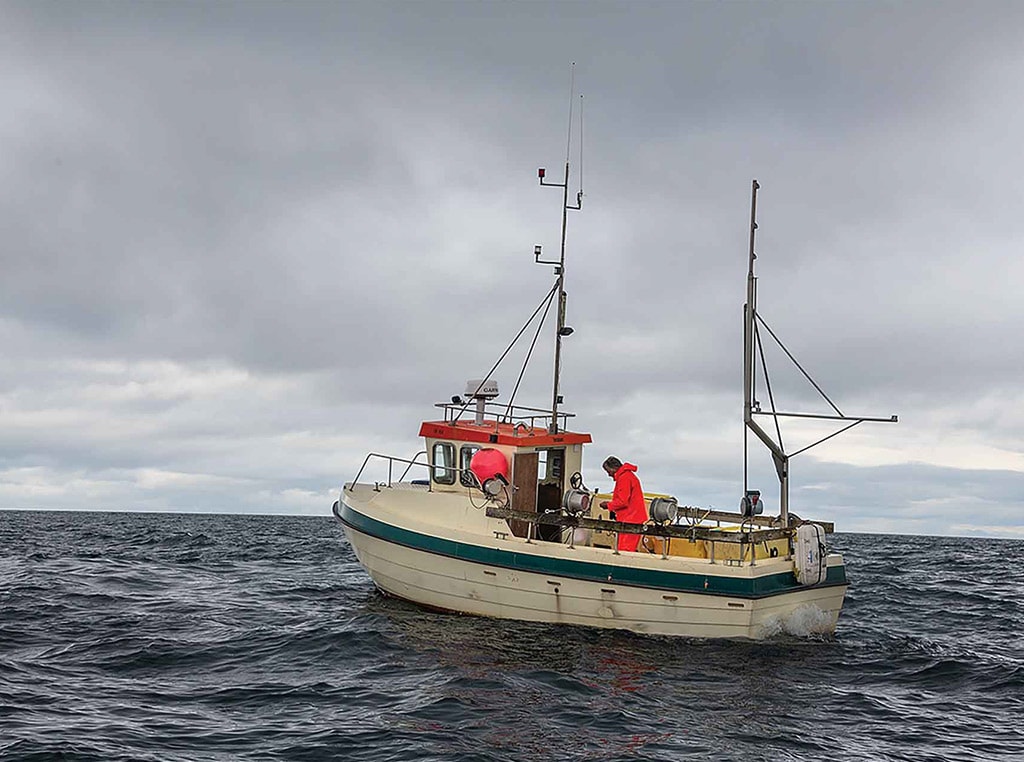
[333,148,896,639]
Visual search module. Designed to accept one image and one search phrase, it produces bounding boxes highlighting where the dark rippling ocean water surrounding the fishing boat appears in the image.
[0,511,1024,762]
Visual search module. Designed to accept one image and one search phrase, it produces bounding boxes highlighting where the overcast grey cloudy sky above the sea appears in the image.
[0,0,1024,538]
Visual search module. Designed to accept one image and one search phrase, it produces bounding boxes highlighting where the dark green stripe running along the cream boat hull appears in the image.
[340,501,847,598]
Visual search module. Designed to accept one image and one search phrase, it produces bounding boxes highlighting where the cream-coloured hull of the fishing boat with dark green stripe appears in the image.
[340,487,847,639]
